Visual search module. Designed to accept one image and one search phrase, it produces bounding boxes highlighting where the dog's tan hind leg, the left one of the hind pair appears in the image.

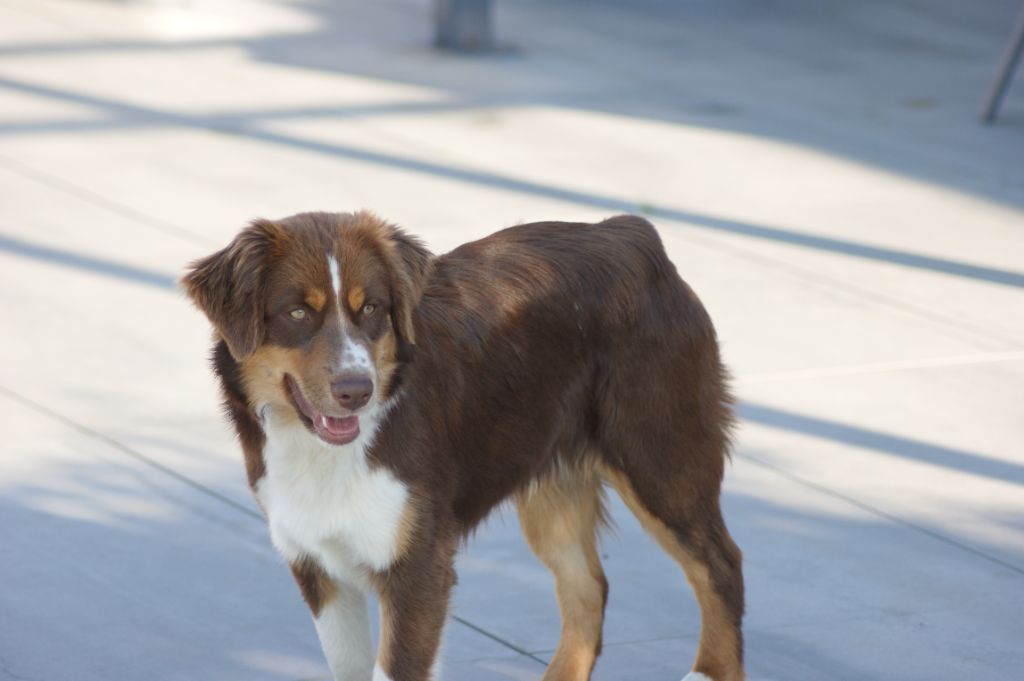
[518,469,608,681]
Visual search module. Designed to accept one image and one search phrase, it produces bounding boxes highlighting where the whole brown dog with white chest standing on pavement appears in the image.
[183,213,743,681]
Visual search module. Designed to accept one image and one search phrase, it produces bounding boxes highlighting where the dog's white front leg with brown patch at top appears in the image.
[292,558,377,681]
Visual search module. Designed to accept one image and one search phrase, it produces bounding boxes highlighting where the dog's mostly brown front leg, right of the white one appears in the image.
[374,547,455,681]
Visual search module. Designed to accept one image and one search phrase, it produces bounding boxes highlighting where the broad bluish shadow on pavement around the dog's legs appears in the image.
[0,446,1019,681]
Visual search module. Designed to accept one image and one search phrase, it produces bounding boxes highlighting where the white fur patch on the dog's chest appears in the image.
[256,409,409,583]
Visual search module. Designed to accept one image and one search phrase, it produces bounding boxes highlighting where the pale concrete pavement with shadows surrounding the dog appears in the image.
[0,0,1024,681]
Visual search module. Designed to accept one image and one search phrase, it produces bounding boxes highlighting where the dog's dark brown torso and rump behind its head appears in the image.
[382,216,731,526]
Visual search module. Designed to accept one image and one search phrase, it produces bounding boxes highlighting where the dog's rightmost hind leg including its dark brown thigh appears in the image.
[595,313,743,681]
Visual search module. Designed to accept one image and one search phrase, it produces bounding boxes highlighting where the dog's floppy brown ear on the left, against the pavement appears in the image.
[181,220,282,361]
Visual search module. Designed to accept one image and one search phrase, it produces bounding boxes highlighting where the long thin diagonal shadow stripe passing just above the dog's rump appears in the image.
[0,78,1024,288]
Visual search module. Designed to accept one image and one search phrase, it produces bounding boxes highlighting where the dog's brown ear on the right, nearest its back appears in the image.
[387,226,434,361]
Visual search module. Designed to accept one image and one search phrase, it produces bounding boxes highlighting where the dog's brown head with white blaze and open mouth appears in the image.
[182,212,431,444]
